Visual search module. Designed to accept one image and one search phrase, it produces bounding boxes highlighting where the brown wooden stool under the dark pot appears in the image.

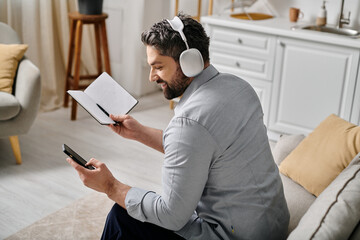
[64,12,111,120]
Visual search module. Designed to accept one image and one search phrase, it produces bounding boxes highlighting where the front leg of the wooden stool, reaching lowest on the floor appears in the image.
[71,21,83,120]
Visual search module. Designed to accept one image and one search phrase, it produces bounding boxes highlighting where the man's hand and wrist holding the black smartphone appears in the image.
[66,158,131,208]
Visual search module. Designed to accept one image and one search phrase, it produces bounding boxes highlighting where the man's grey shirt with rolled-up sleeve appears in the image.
[125,65,289,240]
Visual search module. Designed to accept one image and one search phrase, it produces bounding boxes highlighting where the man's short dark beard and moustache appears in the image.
[157,67,190,100]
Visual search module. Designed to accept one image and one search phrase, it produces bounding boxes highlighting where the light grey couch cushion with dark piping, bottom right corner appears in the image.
[288,153,360,240]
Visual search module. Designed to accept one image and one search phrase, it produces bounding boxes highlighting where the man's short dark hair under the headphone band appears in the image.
[141,13,210,63]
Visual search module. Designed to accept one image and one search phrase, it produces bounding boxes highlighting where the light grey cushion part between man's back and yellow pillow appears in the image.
[273,134,305,166]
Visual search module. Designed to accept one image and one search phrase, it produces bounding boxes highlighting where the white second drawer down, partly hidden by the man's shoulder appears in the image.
[210,52,273,81]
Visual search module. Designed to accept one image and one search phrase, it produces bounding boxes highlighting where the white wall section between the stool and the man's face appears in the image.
[103,0,169,97]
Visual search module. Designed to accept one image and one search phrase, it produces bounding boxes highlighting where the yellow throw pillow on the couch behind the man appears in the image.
[279,114,360,196]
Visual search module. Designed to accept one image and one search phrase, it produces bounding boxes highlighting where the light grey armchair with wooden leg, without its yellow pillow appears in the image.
[0,22,41,164]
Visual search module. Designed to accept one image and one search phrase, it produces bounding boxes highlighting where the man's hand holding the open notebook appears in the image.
[109,114,144,140]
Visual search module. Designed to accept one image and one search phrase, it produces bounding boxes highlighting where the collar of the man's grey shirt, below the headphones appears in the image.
[174,64,219,114]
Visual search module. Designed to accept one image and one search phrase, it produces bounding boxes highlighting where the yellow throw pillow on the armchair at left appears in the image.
[0,44,28,93]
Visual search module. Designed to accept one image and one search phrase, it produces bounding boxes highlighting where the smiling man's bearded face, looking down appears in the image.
[146,45,192,100]
